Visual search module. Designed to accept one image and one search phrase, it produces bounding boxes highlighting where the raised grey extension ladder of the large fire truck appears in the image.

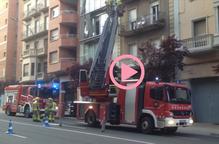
[89,2,118,89]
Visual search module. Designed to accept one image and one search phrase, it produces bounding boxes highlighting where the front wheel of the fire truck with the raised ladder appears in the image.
[141,116,154,134]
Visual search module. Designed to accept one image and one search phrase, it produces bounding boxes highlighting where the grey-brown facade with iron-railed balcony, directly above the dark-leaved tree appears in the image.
[120,0,170,56]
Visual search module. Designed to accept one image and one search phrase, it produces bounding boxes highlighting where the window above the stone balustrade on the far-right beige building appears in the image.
[194,18,206,37]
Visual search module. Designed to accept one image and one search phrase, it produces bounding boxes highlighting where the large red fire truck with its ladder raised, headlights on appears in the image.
[75,3,193,133]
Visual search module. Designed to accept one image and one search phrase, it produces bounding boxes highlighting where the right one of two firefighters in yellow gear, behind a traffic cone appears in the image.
[45,98,57,122]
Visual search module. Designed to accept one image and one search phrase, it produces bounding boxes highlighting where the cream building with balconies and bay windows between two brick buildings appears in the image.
[21,0,49,83]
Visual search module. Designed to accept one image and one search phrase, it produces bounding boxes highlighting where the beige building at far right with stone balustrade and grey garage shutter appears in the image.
[173,0,219,123]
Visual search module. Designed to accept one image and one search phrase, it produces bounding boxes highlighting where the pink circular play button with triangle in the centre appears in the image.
[109,54,145,90]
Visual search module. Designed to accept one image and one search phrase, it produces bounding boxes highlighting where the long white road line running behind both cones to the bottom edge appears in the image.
[0,119,155,144]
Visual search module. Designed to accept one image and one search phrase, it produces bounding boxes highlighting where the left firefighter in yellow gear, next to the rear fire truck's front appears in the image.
[32,97,40,122]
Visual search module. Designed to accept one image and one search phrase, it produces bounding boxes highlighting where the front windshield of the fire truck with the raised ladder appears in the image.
[166,86,191,104]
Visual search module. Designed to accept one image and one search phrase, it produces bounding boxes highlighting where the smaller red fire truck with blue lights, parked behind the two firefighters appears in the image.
[3,85,57,118]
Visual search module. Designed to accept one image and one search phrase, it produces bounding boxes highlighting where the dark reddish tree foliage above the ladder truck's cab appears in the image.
[139,36,188,82]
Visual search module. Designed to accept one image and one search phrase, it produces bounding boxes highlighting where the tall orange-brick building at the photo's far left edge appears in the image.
[0,0,19,82]
